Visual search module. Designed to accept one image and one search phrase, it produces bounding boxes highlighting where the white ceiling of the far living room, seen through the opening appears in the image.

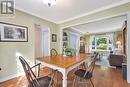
[71,16,126,34]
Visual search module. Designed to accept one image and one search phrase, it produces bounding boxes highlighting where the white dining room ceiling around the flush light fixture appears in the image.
[15,0,128,24]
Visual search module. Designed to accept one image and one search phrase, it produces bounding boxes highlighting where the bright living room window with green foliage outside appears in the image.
[91,35,113,50]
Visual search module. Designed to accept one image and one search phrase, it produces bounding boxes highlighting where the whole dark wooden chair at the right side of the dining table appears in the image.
[72,53,98,87]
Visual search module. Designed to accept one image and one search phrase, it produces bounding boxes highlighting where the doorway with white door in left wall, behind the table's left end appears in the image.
[35,25,50,58]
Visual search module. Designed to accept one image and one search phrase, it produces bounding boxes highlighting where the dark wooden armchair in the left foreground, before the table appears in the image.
[19,56,56,87]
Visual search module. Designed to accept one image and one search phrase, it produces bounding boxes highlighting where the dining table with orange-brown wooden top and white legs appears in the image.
[36,53,90,87]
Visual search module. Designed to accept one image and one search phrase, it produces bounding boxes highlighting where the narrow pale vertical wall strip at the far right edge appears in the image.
[127,12,130,83]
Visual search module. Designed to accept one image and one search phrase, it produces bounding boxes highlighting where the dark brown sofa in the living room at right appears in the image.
[108,54,124,67]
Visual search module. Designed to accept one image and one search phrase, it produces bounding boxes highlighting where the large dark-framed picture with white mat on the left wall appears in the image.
[0,22,28,42]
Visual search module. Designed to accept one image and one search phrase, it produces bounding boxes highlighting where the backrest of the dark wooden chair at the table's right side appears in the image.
[84,53,98,77]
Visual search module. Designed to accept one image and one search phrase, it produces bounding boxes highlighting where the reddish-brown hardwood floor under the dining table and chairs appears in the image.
[0,66,130,87]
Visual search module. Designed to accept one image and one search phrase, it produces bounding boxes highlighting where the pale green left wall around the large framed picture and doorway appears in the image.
[0,10,60,82]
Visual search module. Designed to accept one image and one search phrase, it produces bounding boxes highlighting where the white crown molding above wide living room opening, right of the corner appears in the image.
[56,0,130,24]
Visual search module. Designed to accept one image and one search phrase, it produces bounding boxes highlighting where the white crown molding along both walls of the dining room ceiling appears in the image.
[16,0,130,24]
